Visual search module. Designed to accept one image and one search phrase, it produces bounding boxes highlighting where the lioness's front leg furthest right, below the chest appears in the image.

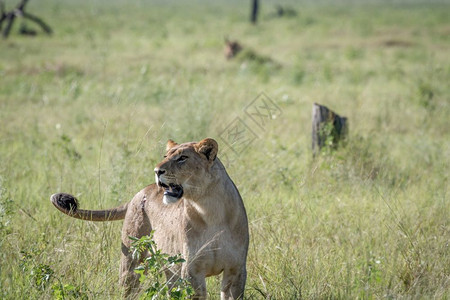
[220,265,247,300]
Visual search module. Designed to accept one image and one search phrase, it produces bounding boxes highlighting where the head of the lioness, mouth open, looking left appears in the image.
[155,138,218,204]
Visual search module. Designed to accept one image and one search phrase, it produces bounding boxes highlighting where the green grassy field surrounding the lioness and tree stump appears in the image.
[0,0,450,299]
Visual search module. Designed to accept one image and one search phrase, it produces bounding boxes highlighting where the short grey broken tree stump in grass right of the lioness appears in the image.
[312,103,348,155]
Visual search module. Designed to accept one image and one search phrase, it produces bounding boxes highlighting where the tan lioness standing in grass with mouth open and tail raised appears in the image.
[51,138,249,299]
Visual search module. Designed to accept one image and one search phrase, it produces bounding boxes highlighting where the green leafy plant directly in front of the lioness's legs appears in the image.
[129,231,194,299]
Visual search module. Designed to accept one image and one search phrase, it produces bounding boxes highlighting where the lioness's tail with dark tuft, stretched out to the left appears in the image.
[50,193,128,221]
